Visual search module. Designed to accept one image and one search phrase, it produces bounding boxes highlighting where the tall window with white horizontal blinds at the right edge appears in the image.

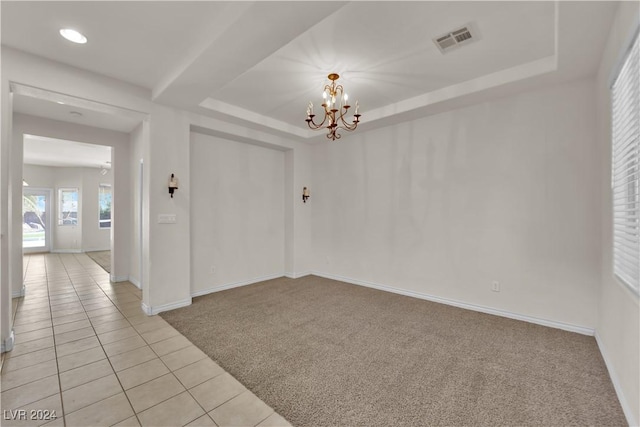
[611,31,640,293]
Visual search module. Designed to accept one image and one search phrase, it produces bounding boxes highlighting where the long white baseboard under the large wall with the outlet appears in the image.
[311,271,595,336]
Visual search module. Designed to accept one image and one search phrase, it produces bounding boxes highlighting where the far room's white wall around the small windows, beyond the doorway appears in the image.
[23,165,112,252]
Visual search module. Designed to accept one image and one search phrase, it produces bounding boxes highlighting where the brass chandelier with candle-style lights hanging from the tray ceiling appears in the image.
[305,73,360,141]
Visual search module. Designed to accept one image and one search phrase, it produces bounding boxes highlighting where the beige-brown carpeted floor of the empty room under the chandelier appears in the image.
[161,276,626,426]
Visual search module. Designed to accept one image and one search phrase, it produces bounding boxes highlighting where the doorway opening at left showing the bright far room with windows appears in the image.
[22,134,113,260]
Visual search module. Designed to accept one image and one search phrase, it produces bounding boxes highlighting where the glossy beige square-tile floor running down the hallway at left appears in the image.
[0,254,289,427]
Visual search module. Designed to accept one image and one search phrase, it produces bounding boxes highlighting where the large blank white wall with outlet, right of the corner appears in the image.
[312,80,600,333]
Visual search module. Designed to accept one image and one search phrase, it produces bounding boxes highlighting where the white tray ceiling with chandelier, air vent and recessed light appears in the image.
[1,1,617,139]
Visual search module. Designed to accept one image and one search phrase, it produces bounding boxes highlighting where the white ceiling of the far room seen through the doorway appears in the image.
[24,135,111,169]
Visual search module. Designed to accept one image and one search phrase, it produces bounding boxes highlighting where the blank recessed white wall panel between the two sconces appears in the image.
[190,133,285,295]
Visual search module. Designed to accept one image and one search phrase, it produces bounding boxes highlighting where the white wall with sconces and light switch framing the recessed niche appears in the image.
[143,104,310,313]
